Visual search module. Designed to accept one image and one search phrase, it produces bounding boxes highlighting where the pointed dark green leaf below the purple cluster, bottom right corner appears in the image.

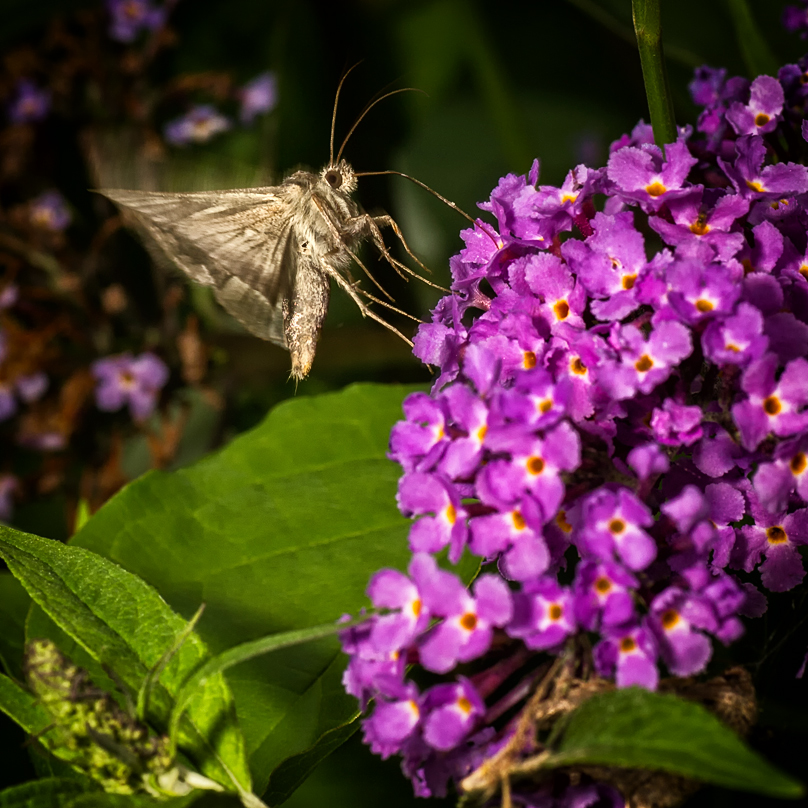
[546,687,803,798]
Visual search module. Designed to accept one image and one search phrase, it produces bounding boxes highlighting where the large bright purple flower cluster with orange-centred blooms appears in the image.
[343,52,808,806]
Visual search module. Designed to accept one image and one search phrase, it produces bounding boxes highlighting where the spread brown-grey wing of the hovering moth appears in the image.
[101,187,298,349]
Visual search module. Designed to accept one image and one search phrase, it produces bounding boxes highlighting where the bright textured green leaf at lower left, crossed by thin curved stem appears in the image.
[0,526,249,789]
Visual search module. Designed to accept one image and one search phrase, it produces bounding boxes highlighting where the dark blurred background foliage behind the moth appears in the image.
[0,0,804,808]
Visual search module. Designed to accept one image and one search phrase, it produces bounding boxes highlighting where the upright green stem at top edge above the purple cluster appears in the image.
[631,0,676,149]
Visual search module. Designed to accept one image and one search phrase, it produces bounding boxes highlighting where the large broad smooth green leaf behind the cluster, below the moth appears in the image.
[73,385,411,804]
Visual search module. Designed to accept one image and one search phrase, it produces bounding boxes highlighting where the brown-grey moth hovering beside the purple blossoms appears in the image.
[100,71,432,380]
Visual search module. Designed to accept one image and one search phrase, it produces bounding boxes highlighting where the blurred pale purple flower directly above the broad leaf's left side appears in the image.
[92,353,168,421]
